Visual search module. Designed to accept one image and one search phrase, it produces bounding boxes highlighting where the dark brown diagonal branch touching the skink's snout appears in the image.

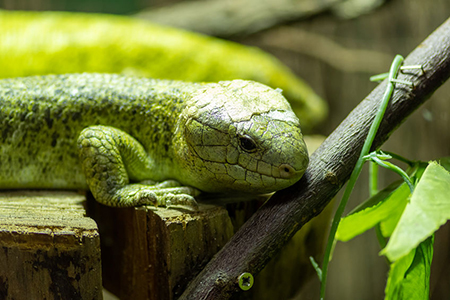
[180,19,450,300]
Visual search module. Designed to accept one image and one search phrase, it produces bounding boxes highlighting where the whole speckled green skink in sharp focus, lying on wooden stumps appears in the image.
[0,74,308,206]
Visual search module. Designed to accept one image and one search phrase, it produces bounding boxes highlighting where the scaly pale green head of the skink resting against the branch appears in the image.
[178,80,309,194]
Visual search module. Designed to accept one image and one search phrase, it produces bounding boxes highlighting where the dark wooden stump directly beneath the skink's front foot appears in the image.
[92,204,233,300]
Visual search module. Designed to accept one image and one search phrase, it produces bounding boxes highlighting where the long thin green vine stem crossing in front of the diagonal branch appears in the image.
[320,55,403,299]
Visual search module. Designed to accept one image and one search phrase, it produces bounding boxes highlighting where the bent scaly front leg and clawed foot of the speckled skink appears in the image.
[78,125,199,209]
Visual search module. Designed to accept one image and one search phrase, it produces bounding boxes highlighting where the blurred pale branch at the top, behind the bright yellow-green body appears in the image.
[135,0,343,37]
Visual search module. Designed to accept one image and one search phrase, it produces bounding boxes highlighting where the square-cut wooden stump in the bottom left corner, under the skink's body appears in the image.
[0,191,102,300]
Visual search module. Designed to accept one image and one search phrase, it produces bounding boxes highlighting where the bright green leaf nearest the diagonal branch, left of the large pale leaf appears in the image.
[336,182,410,242]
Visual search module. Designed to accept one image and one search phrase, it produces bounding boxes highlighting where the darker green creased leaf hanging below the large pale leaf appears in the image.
[385,236,434,300]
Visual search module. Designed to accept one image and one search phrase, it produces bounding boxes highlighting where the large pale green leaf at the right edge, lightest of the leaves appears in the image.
[381,162,450,261]
